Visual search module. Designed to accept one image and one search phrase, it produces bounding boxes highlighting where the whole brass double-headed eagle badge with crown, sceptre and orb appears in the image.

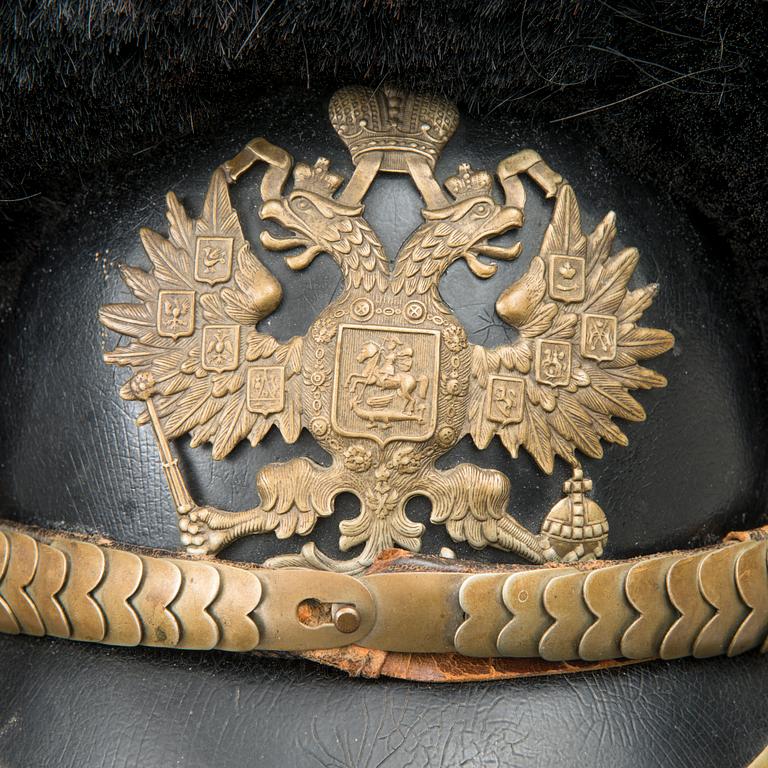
[100,87,674,573]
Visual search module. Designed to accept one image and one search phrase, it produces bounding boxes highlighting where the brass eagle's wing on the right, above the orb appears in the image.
[467,185,674,473]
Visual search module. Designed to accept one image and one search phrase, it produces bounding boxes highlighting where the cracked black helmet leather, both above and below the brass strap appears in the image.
[0,88,768,768]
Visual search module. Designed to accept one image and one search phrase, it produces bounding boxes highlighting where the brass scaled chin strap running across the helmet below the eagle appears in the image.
[0,524,768,662]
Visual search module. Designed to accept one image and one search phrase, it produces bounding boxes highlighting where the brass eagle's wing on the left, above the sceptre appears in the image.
[100,170,301,459]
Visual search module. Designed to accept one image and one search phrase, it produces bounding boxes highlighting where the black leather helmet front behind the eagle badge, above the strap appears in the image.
[0,94,767,560]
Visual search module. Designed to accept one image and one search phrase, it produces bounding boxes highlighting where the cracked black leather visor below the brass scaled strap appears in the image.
[0,637,768,768]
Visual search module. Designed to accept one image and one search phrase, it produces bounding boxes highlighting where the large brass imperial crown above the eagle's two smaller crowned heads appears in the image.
[328,86,459,173]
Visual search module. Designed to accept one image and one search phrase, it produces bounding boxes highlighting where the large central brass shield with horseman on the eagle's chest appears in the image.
[331,325,440,445]
